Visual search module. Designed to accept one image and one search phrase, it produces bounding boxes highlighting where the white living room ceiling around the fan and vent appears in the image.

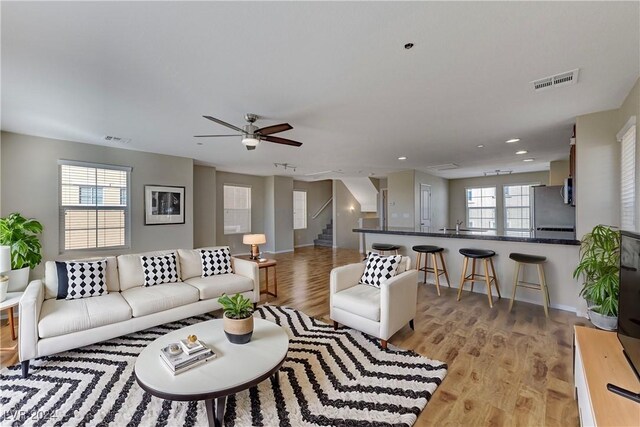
[0,1,640,180]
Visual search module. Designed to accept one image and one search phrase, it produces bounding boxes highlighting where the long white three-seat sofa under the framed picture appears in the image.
[18,247,260,377]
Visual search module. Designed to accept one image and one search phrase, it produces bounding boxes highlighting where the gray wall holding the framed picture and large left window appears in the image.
[1,132,193,274]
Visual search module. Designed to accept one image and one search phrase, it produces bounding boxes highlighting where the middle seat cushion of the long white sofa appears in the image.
[122,283,200,317]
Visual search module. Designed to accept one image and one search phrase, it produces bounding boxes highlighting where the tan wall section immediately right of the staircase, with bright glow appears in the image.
[333,179,362,249]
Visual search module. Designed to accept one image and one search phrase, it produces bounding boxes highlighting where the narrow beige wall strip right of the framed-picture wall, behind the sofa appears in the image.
[193,165,216,248]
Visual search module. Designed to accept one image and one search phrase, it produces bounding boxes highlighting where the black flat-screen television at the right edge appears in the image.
[618,231,640,378]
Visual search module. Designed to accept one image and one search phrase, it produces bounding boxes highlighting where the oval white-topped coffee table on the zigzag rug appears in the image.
[134,318,289,426]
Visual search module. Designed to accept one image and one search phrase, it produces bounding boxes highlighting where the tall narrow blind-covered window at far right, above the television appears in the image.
[620,126,636,230]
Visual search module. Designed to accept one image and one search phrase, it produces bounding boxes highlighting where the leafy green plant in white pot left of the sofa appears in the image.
[0,213,43,290]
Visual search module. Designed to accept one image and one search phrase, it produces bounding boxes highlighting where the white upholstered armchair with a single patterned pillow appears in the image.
[329,256,418,348]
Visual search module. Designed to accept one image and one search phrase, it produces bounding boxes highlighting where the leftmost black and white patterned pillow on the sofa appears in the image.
[56,260,109,300]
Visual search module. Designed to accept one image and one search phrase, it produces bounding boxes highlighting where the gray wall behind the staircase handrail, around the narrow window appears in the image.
[293,180,333,247]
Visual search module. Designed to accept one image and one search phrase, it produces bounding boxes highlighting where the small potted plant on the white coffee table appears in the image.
[218,294,253,344]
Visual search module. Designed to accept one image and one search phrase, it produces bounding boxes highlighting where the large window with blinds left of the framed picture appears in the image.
[60,161,131,251]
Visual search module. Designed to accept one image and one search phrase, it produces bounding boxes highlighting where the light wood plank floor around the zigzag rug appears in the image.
[0,247,588,426]
